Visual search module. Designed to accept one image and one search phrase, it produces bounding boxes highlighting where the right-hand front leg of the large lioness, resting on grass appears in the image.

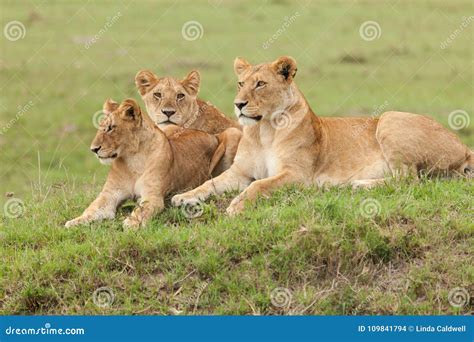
[226,172,298,216]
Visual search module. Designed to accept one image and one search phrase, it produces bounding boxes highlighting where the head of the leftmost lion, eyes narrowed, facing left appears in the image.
[91,99,142,164]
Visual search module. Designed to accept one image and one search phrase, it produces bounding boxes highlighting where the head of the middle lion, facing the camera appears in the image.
[135,70,200,128]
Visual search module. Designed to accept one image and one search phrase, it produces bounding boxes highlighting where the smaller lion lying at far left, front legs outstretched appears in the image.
[65,99,240,229]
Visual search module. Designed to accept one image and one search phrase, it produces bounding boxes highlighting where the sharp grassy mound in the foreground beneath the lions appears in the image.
[0,180,474,314]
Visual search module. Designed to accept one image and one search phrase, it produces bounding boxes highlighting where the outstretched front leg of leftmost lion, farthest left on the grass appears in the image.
[64,191,126,228]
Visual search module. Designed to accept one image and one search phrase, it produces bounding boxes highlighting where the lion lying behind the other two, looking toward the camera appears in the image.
[135,70,241,176]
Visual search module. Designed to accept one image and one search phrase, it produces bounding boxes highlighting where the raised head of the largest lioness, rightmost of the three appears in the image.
[234,56,297,125]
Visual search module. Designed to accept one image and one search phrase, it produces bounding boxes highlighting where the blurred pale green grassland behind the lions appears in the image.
[0,0,474,203]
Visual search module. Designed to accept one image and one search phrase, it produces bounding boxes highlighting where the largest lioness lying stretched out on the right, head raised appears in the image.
[172,57,474,214]
